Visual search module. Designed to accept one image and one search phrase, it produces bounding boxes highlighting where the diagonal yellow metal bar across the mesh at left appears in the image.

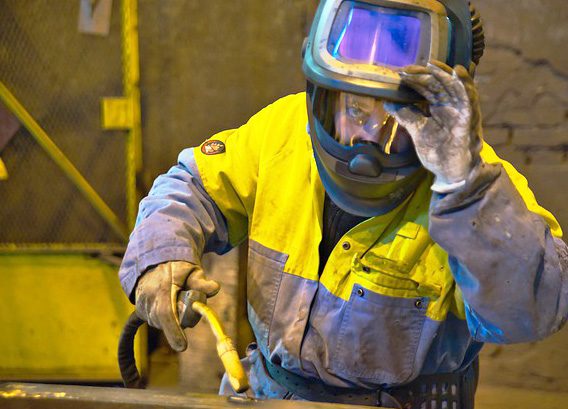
[0,81,128,241]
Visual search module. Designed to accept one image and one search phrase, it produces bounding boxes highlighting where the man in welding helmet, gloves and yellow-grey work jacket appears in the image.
[120,0,568,409]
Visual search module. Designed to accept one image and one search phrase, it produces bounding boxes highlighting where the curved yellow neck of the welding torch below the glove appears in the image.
[191,301,249,393]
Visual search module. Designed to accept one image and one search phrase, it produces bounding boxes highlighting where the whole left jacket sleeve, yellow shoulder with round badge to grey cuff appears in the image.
[119,94,274,300]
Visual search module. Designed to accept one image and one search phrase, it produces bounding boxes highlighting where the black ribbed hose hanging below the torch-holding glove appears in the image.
[118,311,146,389]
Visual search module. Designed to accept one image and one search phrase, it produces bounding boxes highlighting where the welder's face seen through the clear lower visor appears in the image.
[334,92,413,154]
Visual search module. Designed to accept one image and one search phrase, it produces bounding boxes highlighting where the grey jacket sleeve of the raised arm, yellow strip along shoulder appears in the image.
[429,145,568,344]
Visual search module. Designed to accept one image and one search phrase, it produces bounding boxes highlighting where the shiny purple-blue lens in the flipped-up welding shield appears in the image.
[327,1,426,67]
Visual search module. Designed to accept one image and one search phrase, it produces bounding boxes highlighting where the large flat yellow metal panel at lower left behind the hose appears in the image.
[0,254,146,381]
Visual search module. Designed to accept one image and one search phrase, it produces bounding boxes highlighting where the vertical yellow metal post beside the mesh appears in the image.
[122,0,142,228]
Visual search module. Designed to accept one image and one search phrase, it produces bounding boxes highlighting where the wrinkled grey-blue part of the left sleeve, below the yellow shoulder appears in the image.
[119,149,230,300]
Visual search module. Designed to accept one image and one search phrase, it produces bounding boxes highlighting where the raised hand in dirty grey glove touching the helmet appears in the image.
[385,62,482,193]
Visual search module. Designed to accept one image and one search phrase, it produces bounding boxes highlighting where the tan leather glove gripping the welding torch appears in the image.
[136,261,220,352]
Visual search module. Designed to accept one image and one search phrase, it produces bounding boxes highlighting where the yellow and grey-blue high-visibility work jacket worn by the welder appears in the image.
[120,94,568,387]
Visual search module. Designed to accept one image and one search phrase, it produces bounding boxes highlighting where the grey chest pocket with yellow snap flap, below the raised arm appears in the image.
[330,222,442,384]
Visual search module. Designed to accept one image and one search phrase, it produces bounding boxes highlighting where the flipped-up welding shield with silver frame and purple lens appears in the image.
[304,0,449,102]
